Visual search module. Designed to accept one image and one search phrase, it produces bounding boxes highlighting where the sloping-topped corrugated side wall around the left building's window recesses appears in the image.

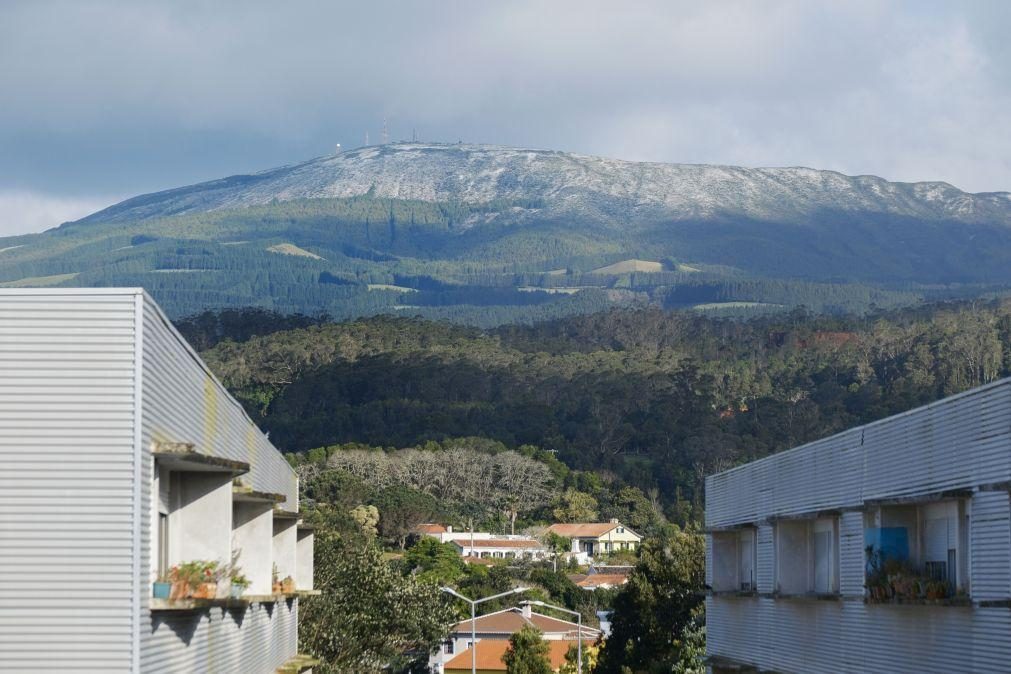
[140,295,298,674]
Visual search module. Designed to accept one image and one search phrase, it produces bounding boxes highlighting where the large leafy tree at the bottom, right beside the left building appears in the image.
[298,532,455,674]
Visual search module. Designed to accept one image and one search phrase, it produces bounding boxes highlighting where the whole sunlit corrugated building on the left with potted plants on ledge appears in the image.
[0,288,312,674]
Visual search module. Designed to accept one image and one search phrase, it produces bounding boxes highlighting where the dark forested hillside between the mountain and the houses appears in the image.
[181,302,1011,518]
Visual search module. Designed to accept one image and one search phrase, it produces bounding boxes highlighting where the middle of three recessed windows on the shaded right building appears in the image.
[775,517,839,594]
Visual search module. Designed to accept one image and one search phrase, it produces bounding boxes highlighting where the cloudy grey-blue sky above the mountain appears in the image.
[0,0,1011,235]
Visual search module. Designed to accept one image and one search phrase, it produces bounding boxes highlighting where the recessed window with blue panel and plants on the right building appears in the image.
[864,498,970,599]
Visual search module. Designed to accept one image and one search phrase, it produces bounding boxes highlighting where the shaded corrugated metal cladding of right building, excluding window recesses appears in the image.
[706,380,1011,672]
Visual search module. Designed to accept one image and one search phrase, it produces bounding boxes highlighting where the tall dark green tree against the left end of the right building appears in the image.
[595,527,706,674]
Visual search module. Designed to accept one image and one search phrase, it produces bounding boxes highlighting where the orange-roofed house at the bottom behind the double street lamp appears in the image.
[429,605,601,674]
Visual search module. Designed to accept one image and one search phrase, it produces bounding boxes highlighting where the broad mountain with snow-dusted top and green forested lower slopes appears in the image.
[0,142,1011,325]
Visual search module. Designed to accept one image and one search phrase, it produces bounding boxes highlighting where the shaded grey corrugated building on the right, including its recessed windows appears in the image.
[706,380,1011,673]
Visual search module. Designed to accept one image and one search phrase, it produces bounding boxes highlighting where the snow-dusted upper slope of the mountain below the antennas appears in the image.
[85,142,1011,225]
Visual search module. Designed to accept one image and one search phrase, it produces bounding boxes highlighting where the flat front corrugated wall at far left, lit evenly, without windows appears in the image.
[0,289,135,672]
